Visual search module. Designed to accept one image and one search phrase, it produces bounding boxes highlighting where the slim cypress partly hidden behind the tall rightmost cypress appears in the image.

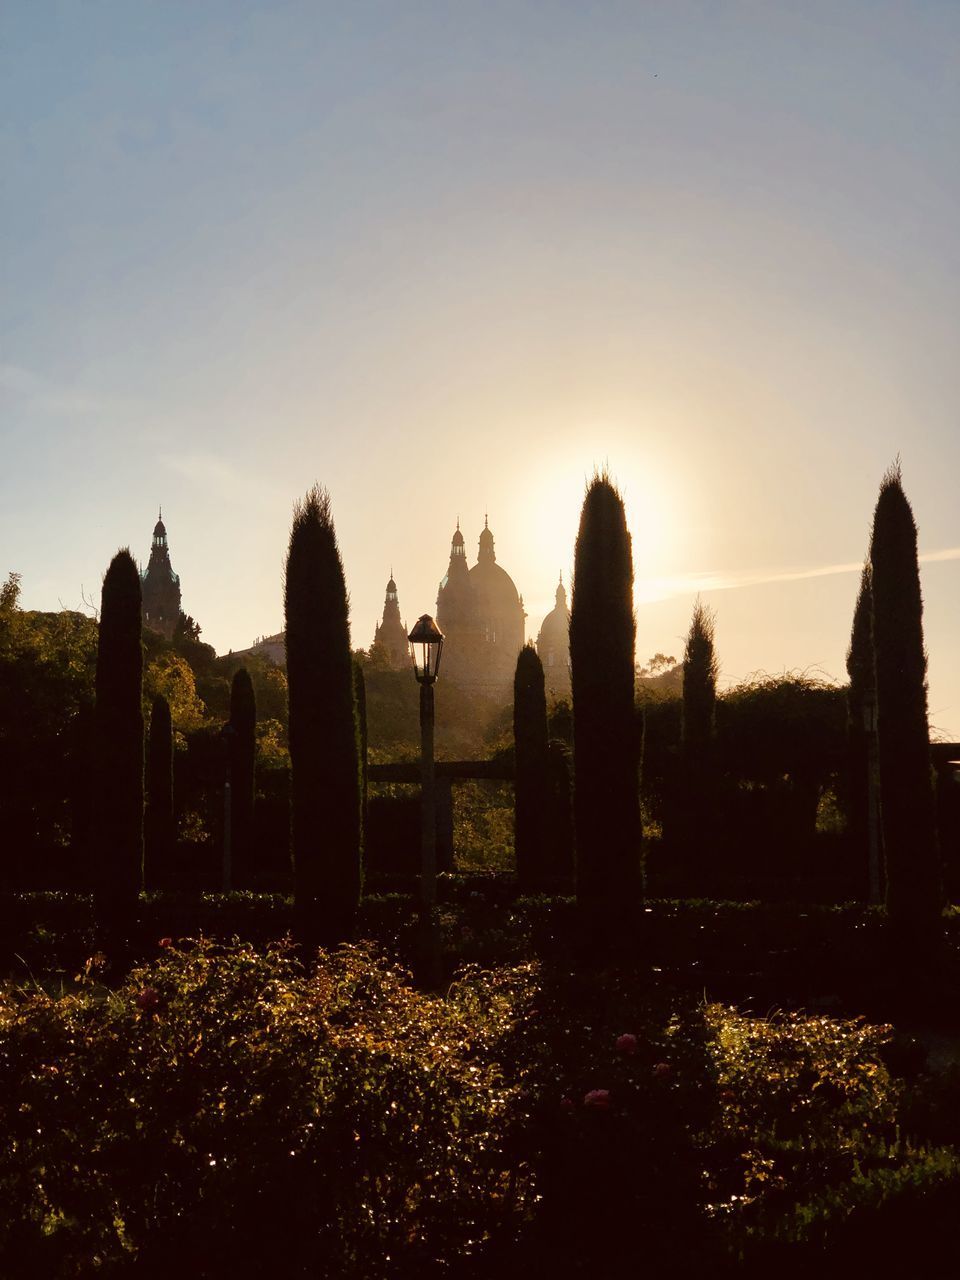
[846,563,879,900]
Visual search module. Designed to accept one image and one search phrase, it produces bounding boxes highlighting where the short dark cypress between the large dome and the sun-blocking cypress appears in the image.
[513,644,553,893]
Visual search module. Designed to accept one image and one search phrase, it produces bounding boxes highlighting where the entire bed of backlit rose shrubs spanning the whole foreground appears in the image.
[0,934,960,1280]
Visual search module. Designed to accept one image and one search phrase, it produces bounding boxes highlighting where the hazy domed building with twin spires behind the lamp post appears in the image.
[436,520,526,696]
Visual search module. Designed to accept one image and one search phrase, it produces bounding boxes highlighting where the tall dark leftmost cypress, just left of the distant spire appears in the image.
[92,549,143,931]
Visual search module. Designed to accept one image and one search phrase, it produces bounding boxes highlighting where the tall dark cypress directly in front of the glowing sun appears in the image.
[570,474,640,947]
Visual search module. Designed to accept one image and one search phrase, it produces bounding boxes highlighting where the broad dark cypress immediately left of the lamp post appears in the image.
[284,486,361,947]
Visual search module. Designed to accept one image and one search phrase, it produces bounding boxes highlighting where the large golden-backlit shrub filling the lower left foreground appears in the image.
[0,942,529,1277]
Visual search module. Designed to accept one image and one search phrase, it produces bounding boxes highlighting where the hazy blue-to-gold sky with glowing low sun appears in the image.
[0,0,960,741]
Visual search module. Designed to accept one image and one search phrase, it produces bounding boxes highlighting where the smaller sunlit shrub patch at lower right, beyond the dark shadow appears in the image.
[707,1005,960,1274]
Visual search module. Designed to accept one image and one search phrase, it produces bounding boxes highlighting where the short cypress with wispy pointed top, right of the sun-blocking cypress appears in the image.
[677,599,718,892]
